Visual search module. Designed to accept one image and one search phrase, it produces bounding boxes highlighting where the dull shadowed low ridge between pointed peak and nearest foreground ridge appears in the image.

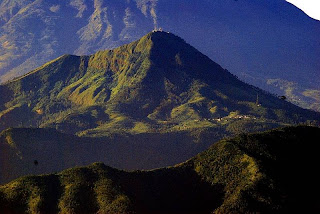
[0,128,228,184]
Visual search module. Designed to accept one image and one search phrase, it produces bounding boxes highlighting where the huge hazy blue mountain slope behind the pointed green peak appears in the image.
[0,0,320,111]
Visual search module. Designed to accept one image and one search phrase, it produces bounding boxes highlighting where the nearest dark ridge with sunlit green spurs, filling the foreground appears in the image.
[0,126,320,213]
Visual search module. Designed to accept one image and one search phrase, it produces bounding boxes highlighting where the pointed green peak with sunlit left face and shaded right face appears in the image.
[0,32,320,136]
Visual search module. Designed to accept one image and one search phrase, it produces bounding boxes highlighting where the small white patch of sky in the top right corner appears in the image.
[287,0,320,20]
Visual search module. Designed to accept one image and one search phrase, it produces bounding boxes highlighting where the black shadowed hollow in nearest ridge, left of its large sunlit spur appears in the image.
[119,167,224,214]
